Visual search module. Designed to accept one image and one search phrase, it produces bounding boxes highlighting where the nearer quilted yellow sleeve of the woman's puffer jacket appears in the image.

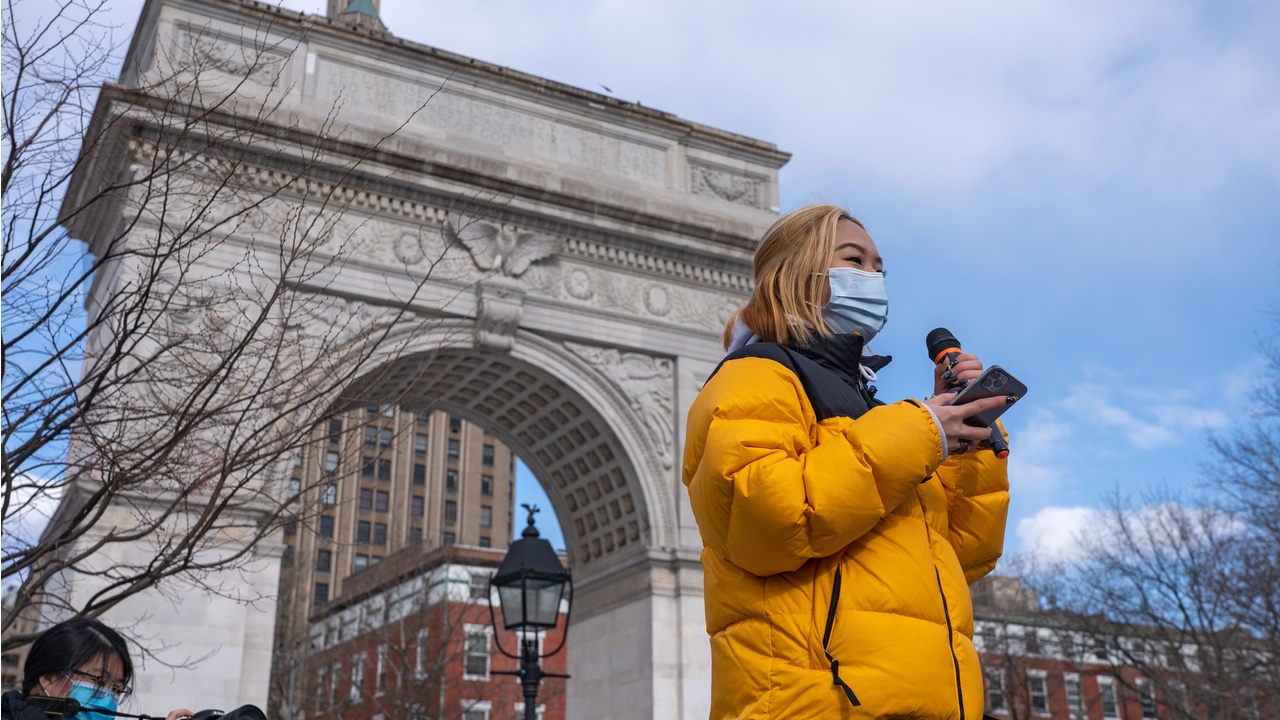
[684,357,942,575]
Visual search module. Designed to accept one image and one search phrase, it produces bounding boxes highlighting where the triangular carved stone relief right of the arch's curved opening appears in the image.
[564,342,676,469]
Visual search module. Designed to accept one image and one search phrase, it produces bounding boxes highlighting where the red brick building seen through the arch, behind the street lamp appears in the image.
[296,546,568,720]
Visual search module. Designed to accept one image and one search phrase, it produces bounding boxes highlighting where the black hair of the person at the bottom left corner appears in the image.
[22,618,133,696]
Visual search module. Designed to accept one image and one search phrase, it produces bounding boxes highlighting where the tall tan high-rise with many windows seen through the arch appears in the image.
[271,405,516,705]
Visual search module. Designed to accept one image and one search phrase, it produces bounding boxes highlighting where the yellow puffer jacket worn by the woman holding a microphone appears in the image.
[684,346,1009,720]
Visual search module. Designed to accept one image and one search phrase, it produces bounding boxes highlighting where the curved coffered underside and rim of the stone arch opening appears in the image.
[346,320,677,577]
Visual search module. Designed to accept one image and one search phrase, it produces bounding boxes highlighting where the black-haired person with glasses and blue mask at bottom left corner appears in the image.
[0,618,192,720]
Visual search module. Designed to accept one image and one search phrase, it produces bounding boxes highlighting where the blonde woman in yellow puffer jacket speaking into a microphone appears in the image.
[684,205,1011,720]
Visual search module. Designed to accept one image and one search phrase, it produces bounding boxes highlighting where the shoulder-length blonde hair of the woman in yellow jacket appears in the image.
[724,205,865,348]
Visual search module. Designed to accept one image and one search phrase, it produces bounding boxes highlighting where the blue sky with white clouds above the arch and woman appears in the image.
[40,0,1280,558]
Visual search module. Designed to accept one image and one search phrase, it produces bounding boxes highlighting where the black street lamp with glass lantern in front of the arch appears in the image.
[489,505,573,720]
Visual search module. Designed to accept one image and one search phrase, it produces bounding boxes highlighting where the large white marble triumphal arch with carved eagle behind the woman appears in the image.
[57,0,788,720]
